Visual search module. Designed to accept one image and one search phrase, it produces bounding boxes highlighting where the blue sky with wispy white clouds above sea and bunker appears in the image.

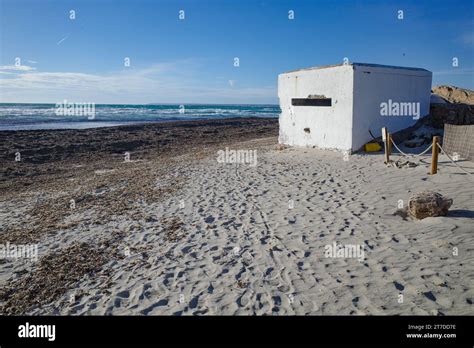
[0,0,474,104]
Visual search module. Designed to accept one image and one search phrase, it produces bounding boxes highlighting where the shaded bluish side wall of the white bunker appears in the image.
[352,65,432,151]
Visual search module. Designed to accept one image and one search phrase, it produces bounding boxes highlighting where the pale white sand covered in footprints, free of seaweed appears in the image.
[2,138,474,315]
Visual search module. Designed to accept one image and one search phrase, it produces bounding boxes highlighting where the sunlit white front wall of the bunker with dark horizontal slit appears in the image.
[278,65,353,150]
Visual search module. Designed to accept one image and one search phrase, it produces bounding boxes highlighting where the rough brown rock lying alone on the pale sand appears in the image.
[408,191,453,219]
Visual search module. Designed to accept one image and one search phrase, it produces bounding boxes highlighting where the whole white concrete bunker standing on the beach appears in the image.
[278,63,432,152]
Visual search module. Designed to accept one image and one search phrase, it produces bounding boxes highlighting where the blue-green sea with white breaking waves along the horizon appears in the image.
[0,103,280,131]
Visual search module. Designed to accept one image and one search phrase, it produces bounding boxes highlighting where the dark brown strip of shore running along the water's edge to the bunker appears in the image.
[0,118,278,194]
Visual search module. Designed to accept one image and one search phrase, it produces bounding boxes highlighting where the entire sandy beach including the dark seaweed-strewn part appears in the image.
[0,119,474,315]
